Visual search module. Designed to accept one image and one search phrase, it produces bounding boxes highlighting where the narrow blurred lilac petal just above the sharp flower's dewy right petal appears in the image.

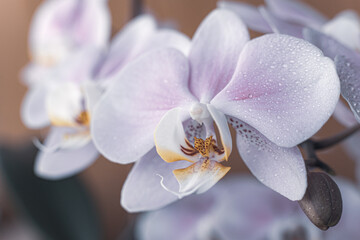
[259,7,303,38]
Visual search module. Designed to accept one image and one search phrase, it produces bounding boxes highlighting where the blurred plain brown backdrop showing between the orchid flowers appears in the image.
[0,0,360,239]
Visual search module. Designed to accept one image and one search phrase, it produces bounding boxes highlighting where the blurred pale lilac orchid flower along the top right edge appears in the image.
[218,0,360,50]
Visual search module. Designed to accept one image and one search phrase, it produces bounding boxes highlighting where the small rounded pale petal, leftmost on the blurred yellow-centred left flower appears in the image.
[21,84,50,128]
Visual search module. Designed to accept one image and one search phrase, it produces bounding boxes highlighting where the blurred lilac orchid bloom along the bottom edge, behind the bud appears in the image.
[135,176,360,240]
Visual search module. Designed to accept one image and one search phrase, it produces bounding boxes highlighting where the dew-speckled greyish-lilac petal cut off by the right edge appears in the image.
[335,56,360,122]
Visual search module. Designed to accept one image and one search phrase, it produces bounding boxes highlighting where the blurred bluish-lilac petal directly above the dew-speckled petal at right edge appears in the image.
[303,28,360,59]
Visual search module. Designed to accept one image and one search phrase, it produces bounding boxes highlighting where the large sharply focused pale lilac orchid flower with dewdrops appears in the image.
[91,10,339,211]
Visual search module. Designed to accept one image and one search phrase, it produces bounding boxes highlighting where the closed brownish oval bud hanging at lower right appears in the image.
[299,172,342,230]
